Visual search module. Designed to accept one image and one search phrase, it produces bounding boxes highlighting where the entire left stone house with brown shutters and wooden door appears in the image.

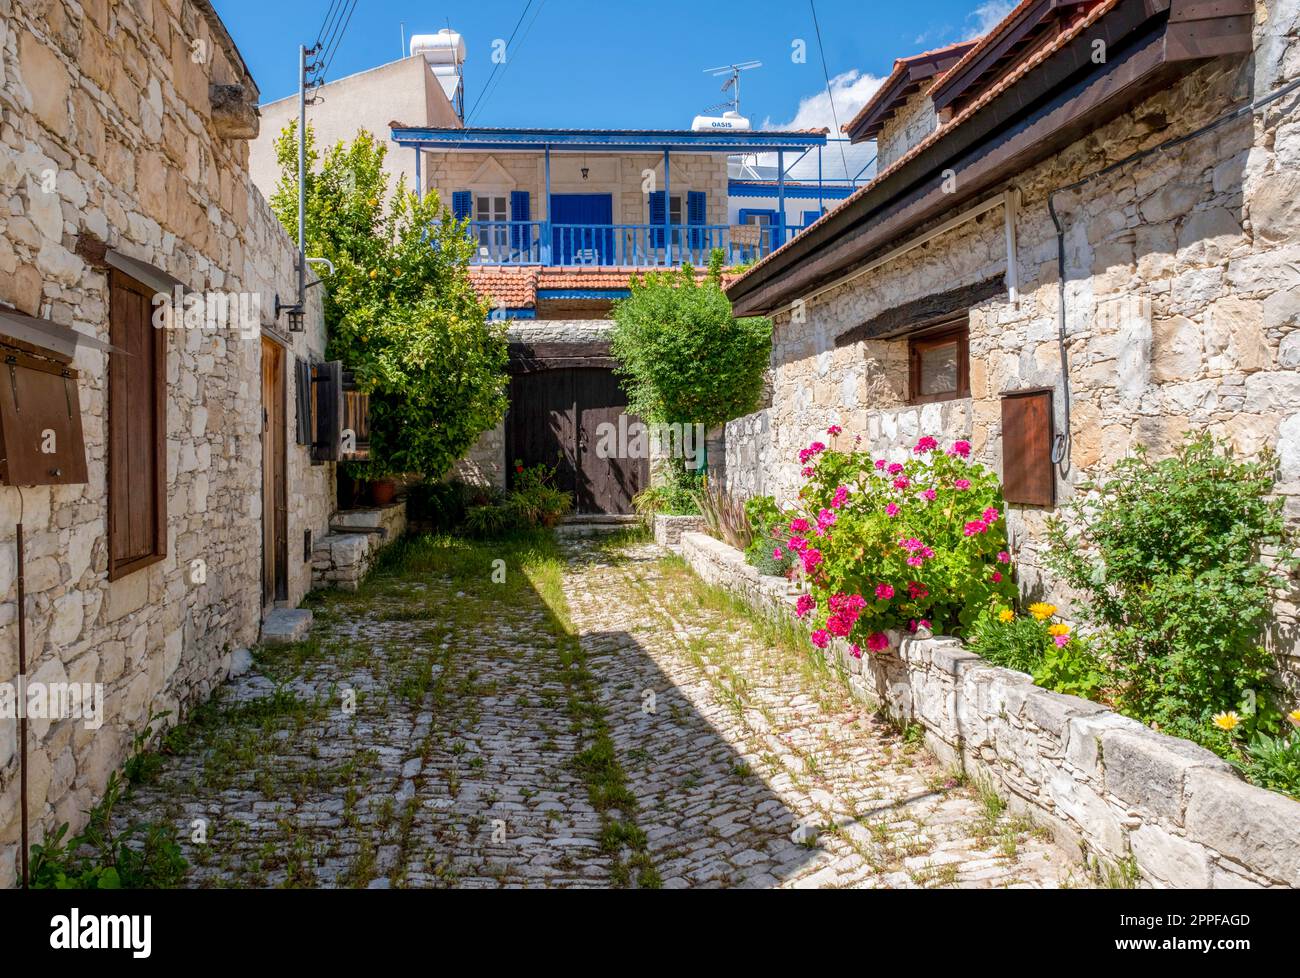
[0,0,334,886]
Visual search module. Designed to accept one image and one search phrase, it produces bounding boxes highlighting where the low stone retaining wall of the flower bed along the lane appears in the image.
[681,533,1300,888]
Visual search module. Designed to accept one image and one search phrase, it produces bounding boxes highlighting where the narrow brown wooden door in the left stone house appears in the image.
[261,337,289,605]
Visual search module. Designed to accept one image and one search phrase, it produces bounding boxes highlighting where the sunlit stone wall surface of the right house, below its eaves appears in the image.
[728,7,1300,681]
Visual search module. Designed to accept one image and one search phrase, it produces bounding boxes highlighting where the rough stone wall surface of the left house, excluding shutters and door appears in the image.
[0,0,333,886]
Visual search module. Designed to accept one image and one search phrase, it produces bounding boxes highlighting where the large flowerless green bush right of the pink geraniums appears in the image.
[1047,436,1295,749]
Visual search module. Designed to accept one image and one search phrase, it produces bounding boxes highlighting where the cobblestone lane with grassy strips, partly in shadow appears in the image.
[117,541,1083,888]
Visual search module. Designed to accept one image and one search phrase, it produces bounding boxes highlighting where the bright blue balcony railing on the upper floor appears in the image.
[454,221,802,268]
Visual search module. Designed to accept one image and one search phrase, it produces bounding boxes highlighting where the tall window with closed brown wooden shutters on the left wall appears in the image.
[108,269,166,580]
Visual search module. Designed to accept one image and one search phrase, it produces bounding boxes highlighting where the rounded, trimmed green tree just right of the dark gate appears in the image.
[612,251,772,429]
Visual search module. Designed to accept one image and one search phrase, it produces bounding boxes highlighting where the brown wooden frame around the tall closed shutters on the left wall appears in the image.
[104,268,166,581]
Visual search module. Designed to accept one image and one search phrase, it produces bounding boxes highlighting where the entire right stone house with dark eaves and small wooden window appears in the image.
[727,0,1300,681]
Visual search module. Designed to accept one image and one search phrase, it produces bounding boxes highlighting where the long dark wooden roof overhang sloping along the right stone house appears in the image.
[727,0,1252,316]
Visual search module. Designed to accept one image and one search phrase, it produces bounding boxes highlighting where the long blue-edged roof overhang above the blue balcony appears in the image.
[391,125,826,153]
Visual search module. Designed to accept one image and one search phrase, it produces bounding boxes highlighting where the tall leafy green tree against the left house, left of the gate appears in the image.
[270,125,507,479]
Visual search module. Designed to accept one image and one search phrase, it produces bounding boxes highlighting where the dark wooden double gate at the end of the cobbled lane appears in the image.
[507,367,650,514]
